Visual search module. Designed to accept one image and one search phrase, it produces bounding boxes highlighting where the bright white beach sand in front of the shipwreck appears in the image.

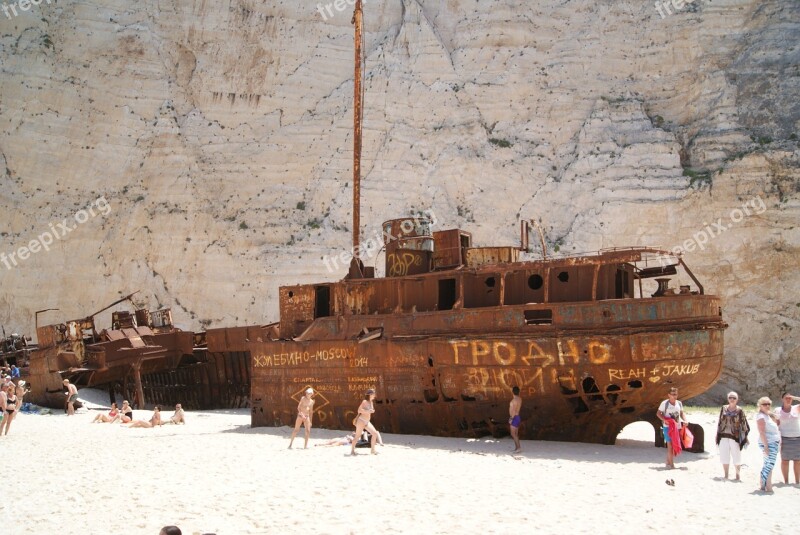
[0,398,800,535]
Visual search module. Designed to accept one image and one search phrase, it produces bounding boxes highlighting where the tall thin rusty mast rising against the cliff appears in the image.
[348,0,364,279]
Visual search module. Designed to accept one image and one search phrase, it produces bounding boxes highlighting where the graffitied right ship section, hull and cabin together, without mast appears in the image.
[248,238,727,444]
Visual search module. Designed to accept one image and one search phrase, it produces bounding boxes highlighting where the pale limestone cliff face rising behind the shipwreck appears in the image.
[0,0,800,402]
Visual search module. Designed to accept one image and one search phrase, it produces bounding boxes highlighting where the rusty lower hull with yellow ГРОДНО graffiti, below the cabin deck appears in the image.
[252,330,722,444]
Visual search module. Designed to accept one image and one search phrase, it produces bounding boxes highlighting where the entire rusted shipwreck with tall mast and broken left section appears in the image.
[23,0,727,444]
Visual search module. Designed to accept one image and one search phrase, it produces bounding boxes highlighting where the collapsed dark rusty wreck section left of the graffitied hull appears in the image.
[22,302,259,410]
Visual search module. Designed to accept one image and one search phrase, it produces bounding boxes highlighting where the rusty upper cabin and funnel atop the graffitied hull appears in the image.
[279,218,719,340]
